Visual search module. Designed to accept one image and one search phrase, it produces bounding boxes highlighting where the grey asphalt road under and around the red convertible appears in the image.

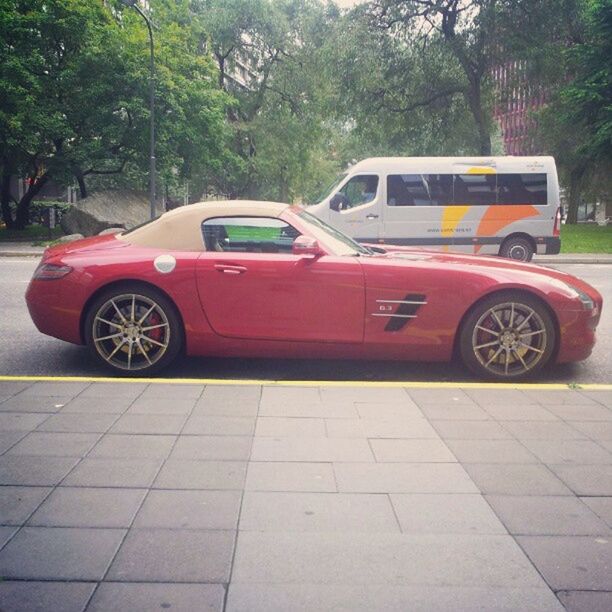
[0,258,612,383]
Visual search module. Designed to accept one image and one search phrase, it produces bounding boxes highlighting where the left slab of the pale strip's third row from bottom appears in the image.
[239,491,400,533]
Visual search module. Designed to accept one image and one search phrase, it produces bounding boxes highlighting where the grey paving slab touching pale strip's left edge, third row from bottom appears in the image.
[134,490,241,529]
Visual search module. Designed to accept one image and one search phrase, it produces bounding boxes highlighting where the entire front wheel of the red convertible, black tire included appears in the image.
[459,291,556,381]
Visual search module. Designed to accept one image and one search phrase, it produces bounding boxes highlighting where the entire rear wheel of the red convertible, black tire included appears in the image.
[84,284,183,376]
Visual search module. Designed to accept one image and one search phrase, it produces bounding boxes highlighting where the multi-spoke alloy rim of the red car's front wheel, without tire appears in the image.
[472,302,548,377]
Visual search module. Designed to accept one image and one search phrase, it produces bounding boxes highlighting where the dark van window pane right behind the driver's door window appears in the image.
[387,174,453,206]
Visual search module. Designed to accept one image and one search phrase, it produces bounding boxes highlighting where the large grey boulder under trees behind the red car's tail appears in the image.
[61,189,163,236]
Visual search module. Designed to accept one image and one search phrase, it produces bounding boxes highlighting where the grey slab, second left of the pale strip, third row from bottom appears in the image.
[28,487,146,528]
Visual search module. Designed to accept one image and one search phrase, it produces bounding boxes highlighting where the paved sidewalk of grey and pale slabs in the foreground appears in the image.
[0,382,612,612]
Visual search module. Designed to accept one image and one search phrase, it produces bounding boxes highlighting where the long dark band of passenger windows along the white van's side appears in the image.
[387,174,548,206]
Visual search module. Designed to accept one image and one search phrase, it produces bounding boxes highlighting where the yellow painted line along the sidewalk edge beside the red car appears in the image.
[0,376,612,391]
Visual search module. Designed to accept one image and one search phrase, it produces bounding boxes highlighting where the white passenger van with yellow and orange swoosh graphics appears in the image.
[308,157,561,261]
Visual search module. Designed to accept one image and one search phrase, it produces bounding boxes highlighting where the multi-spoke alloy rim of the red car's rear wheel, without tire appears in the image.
[92,293,170,371]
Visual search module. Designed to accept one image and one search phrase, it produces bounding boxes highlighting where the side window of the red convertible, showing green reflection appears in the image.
[202,217,300,253]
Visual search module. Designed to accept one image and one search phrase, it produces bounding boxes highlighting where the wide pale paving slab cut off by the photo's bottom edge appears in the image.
[226,583,564,612]
